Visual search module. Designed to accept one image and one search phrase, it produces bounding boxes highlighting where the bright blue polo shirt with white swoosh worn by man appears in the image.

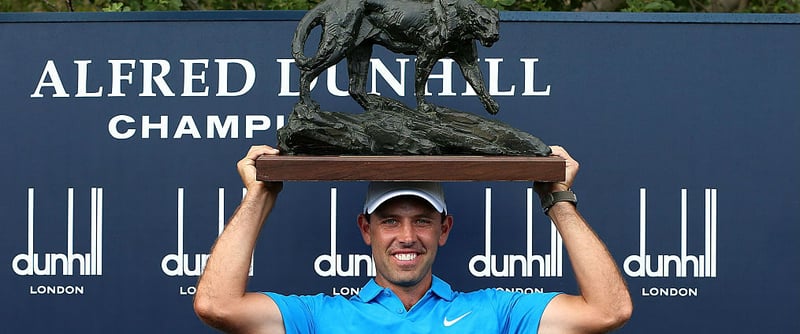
[266,276,558,334]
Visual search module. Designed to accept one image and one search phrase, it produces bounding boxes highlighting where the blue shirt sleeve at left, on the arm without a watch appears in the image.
[264,292,321,334]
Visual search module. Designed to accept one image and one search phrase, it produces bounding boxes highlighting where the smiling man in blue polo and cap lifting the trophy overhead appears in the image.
[194,146,633,333]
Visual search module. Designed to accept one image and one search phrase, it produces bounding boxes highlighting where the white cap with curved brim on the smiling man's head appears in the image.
[364,182,447,214]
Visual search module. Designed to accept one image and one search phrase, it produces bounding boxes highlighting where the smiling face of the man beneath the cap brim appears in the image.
[358,196,453,287]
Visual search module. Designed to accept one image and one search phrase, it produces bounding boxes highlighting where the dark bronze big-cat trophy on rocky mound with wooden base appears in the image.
[256,0,565,181]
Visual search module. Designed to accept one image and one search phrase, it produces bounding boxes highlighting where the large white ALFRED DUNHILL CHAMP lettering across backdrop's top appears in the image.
[29,57,551,140]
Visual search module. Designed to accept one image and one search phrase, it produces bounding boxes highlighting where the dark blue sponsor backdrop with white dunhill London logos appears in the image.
[0,12,800,333]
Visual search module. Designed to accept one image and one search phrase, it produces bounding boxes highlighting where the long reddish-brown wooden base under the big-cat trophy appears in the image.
[256,155,566,182]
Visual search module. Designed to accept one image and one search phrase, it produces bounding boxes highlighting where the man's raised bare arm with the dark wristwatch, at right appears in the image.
[535,146,633,333]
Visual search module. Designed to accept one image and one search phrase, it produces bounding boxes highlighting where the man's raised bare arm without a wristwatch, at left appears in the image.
[194,146,284,333]
